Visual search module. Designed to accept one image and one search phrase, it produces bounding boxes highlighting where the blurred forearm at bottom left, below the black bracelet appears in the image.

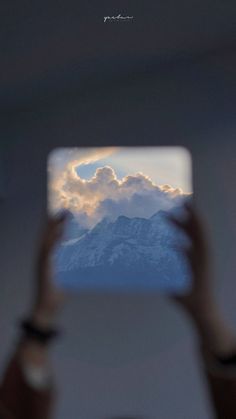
[0,312,55,419]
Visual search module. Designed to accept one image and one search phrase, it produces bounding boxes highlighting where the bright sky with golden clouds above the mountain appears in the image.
[48,147,192,227]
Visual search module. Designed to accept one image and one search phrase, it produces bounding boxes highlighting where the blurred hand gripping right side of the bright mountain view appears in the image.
[168,204,236,355]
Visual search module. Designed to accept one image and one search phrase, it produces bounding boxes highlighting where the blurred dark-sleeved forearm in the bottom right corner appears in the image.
[192,305,236,419]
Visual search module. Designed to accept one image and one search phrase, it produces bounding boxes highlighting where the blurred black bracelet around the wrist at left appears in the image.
[21,320,59,344]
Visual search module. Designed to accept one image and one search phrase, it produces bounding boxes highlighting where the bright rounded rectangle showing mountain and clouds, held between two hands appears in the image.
[48,147,192,292]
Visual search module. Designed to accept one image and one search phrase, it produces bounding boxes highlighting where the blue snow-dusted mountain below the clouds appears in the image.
[56,211,191,290]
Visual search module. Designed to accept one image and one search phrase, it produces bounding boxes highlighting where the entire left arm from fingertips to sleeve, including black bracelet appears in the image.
[0,214,66,419]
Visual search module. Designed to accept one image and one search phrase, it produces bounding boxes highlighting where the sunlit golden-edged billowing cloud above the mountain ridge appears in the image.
[50,159,189,227]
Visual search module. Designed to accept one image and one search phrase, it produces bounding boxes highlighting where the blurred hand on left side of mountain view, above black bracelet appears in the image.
[32,214,66,327]
